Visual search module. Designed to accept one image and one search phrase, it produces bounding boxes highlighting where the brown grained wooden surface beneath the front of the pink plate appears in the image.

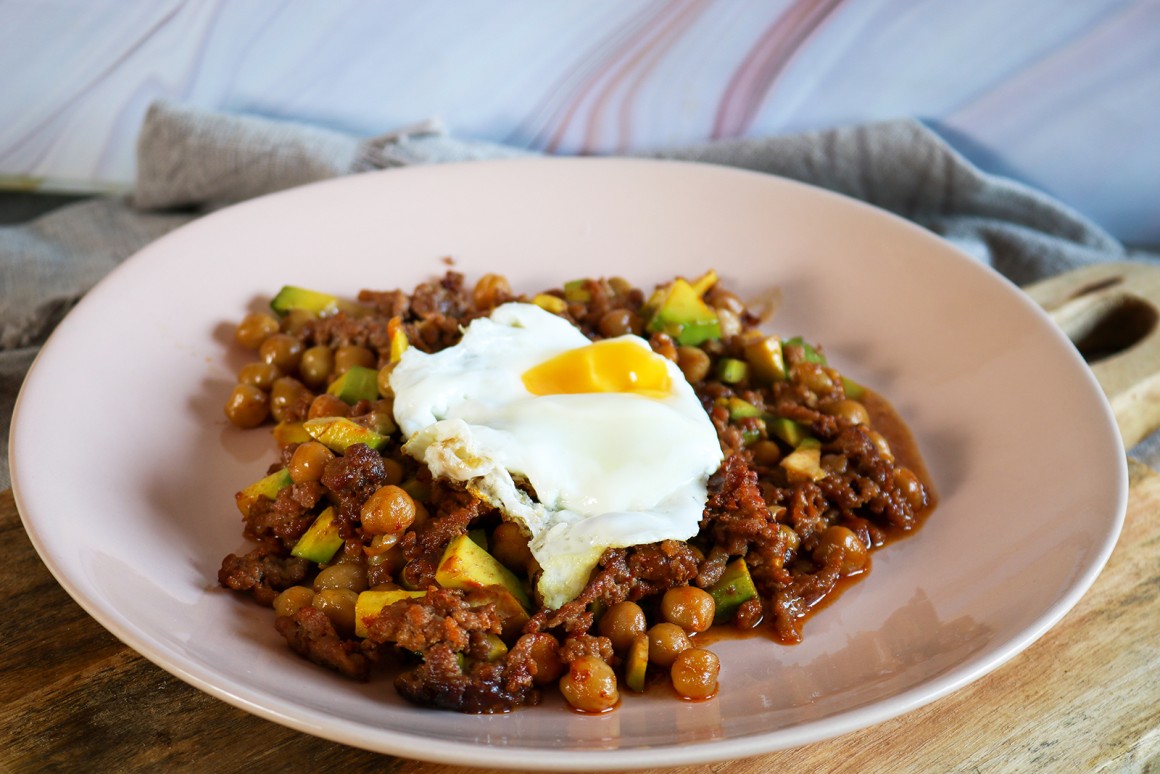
[0,462,1160,774]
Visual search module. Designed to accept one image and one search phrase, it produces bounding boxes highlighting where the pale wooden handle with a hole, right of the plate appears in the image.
[1025,262,1160,448]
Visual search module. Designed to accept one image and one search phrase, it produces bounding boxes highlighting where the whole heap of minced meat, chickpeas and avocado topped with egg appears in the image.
[219,272,933,712]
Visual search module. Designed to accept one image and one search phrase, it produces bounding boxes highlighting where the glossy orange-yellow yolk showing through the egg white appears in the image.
[522,340,670,397]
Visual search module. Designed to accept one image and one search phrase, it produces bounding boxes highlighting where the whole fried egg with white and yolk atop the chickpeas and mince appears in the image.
[391,303,723,609]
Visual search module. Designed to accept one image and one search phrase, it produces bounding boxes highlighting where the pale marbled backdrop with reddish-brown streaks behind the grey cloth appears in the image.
[0,0,1160,244]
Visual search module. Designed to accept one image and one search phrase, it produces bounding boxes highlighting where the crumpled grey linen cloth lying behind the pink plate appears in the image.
[0,103,1160,489]
